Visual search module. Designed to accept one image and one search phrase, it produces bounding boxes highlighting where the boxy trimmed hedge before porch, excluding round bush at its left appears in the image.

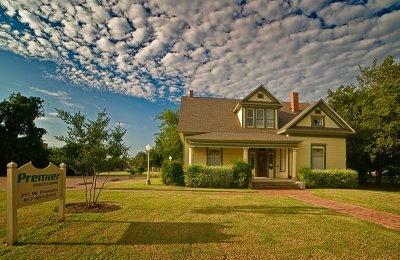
[185,159,252,189]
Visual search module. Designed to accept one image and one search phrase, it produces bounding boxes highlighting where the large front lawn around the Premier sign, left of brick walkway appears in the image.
[0,190,400,259]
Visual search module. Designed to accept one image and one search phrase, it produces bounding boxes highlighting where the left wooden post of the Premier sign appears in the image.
[7,162,18,246]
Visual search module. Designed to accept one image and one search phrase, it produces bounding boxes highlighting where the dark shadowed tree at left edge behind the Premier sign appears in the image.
[0,93,49,172]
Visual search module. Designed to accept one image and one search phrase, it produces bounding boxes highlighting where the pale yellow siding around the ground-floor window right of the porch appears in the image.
[297,137,346,170]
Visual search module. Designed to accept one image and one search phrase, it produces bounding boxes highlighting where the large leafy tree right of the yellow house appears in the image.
[328,56,400,184]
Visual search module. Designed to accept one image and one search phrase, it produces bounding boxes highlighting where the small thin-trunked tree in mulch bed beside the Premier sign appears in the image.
[56,110,129,207]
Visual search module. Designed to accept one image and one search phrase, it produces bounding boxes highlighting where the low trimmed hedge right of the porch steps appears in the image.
[298,167,358,188]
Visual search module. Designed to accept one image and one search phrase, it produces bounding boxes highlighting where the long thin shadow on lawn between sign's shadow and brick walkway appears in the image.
[192,205,342,216]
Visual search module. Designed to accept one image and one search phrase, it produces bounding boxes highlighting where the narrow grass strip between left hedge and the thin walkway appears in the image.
[104,177,256,193]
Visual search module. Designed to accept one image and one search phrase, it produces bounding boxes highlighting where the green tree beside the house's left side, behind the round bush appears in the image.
[155,109,183,164]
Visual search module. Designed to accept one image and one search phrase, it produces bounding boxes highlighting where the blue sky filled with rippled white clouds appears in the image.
[0,0,400,154]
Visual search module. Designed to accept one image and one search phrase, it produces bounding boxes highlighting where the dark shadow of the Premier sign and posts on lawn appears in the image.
[18,220,233,245]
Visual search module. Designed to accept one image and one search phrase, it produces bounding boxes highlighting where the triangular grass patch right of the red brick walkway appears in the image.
[310,189,400,215]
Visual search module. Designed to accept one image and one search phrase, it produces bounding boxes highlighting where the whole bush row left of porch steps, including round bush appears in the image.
[161,161,252,188]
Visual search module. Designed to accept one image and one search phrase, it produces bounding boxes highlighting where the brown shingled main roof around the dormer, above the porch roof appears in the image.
[178,97,310,134]
